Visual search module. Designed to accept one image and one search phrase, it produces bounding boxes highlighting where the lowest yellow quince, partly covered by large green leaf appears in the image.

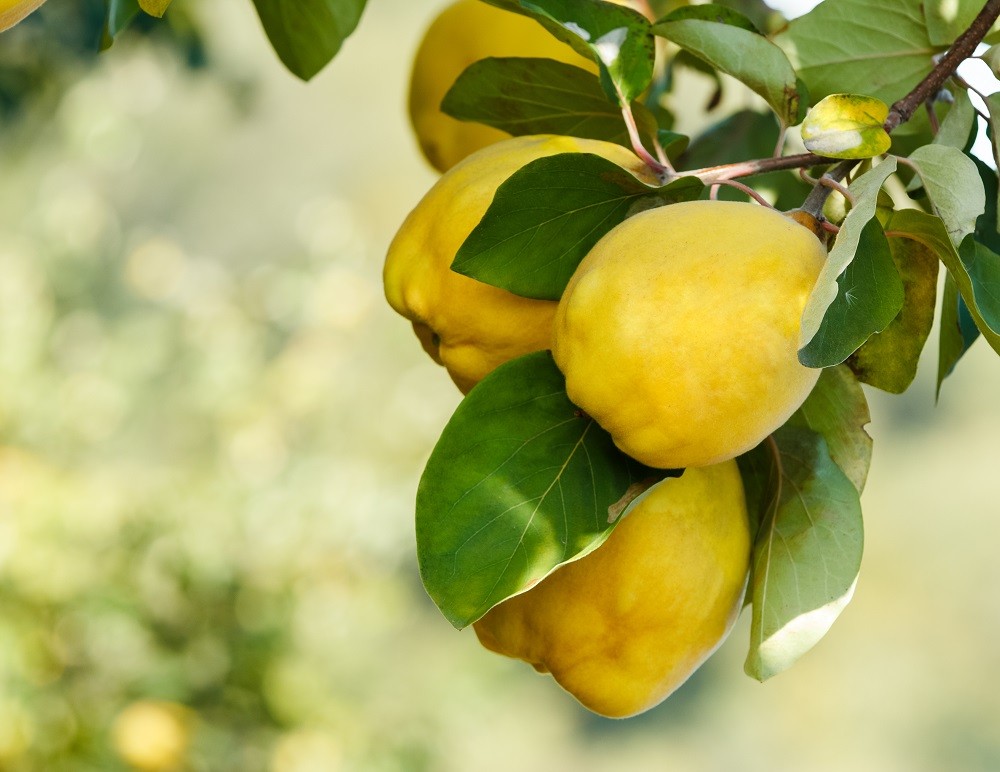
[475,461,751,718]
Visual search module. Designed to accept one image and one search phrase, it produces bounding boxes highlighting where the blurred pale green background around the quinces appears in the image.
[0,0,1000,772]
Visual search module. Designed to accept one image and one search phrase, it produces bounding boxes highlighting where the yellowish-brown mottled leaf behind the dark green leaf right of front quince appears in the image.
[847,238,938,394]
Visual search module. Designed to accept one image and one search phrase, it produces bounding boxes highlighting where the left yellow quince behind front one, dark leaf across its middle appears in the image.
[383,135,652,392]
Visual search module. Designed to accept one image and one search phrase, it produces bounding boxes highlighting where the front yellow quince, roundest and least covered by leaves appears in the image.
[552,201,826,469]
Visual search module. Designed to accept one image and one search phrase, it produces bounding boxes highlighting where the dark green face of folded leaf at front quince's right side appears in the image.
[799,217,904,367]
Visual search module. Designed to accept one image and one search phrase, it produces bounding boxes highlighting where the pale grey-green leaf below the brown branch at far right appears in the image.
[910,145,986,246]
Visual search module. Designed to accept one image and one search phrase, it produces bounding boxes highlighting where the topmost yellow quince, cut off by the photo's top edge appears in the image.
[409,0,640,172]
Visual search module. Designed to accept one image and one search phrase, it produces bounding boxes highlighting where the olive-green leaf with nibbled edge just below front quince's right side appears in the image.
[788,365,872,493]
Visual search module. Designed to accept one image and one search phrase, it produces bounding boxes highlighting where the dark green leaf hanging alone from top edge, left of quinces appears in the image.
[253,0,366,80]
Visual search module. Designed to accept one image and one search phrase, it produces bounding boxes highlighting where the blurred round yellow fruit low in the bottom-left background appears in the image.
[111,700,190,770]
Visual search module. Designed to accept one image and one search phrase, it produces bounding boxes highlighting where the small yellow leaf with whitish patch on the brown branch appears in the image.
[802,94,892,158]
